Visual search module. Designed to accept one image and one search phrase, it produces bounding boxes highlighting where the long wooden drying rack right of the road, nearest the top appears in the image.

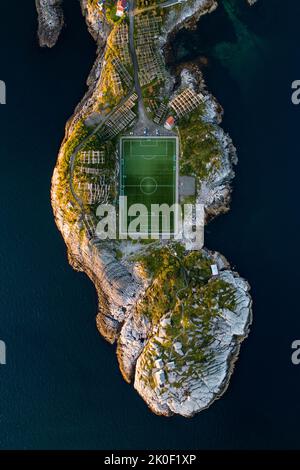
[135,15,165,86]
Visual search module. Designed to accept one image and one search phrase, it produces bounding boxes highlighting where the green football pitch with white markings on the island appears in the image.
[120,137,177,237]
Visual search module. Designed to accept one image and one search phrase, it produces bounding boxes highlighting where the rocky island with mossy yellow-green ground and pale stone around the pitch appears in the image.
[36,0,254,417]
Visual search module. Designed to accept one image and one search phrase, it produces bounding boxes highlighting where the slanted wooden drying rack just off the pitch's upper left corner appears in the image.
[99,93,138,139]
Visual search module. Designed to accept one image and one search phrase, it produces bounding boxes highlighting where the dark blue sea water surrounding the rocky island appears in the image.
[0,0,300,449]
